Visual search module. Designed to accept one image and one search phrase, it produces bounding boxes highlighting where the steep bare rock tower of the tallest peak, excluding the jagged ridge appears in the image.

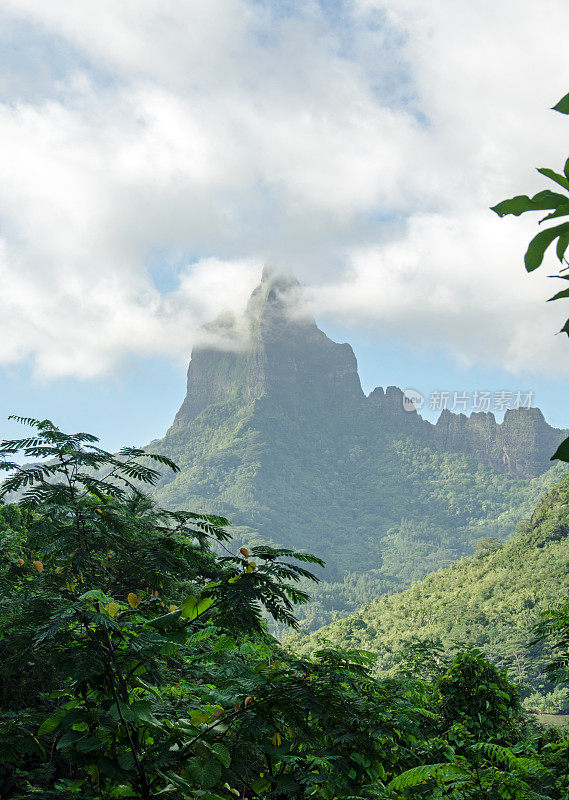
[174,269,365,427]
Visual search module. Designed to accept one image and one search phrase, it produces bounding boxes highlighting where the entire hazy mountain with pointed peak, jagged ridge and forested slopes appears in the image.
[152,274,562,627]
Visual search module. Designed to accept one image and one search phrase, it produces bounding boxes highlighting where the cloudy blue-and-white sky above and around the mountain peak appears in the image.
[0,0,569,447]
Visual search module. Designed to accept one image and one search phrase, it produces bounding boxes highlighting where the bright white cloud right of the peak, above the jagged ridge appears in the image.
[311,210,567,375]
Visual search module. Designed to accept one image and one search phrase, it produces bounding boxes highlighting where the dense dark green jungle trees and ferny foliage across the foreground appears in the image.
[4,420,569,800]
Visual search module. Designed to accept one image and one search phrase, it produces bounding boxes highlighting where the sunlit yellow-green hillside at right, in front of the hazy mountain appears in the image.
[287,477,569,708]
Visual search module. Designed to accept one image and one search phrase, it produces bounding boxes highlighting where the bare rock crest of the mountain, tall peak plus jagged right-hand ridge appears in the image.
[173,269,564,478]
